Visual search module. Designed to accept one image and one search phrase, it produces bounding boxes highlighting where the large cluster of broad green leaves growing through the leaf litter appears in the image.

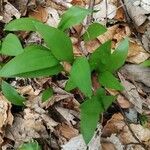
[0,6,129,144]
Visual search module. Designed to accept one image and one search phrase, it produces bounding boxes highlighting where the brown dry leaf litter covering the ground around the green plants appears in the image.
[0,0,150,150]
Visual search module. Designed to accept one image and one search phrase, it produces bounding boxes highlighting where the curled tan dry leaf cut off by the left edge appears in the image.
[0,94,14,145]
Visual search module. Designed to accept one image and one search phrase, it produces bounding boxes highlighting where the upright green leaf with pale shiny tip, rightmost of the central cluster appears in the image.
[107,38,129,72]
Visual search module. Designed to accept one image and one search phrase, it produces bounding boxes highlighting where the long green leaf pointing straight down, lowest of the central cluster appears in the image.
[80,96,103,144]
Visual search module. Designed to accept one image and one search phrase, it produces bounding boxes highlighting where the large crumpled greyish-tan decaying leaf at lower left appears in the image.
[6,99,58,147]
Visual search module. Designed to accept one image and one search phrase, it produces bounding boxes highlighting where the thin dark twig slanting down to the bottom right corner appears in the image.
[117,102,148,150]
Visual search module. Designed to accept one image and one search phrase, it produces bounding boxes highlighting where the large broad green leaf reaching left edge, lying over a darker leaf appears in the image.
[0,49,59,77]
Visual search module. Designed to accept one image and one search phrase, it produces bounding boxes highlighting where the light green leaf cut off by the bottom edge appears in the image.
[17,141,42,150]
